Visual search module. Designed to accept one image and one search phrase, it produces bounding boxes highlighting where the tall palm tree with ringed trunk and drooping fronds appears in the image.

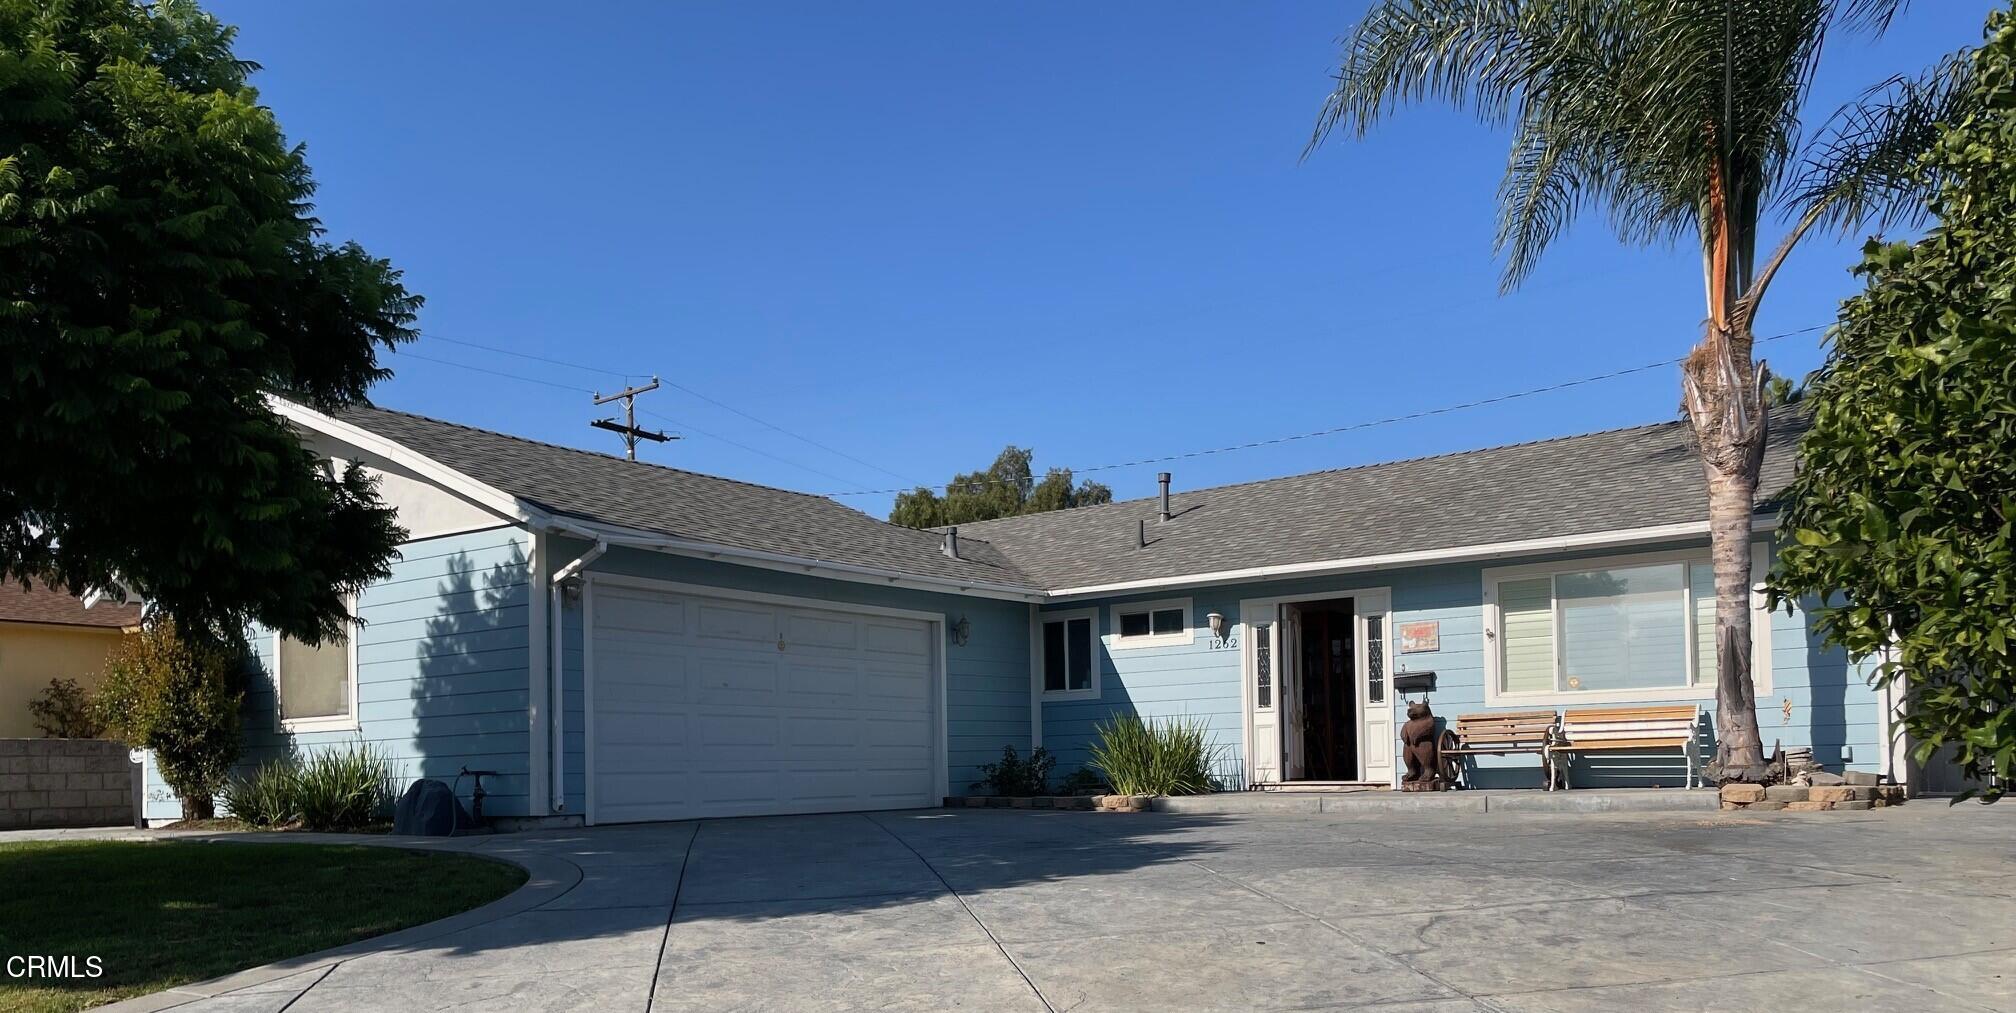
[1310,0,1966,773]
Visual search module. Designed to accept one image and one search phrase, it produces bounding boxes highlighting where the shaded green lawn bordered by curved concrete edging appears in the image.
[0,841,524,1013]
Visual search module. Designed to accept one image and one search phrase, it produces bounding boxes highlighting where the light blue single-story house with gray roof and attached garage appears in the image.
[149,402,1905,823]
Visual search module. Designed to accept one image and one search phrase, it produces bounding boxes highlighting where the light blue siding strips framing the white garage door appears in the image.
[552,539,1030,813]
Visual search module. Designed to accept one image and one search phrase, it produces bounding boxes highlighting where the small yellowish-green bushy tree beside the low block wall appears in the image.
[97,617,246,819]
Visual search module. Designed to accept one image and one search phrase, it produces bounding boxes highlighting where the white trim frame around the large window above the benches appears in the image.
[1475,541,1772,706]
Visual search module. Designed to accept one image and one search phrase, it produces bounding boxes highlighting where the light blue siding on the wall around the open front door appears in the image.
[1042,545,1885,789]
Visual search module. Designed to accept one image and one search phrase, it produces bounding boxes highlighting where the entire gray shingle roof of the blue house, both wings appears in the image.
[339,406,1806,589]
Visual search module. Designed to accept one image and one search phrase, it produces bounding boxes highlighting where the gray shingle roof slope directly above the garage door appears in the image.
[337,406,1032,587]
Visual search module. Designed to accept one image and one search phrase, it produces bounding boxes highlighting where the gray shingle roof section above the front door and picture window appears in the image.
[960,412,1806,591]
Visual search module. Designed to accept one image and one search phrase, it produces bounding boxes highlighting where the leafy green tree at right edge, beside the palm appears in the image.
[1770,12,2016,795]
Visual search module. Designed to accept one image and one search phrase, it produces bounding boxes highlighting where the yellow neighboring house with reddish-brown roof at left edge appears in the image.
[0,581,139,739]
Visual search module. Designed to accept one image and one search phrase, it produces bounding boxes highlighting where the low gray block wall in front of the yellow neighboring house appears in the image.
[0,739,133,829]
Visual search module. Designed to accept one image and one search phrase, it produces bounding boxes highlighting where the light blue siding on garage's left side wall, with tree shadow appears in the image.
[147,527,530,819]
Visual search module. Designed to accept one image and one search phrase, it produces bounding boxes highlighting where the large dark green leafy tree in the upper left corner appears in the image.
[0,0,419,640]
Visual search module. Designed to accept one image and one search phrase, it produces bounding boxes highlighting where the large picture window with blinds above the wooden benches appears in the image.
[1484,551,1770,704]
